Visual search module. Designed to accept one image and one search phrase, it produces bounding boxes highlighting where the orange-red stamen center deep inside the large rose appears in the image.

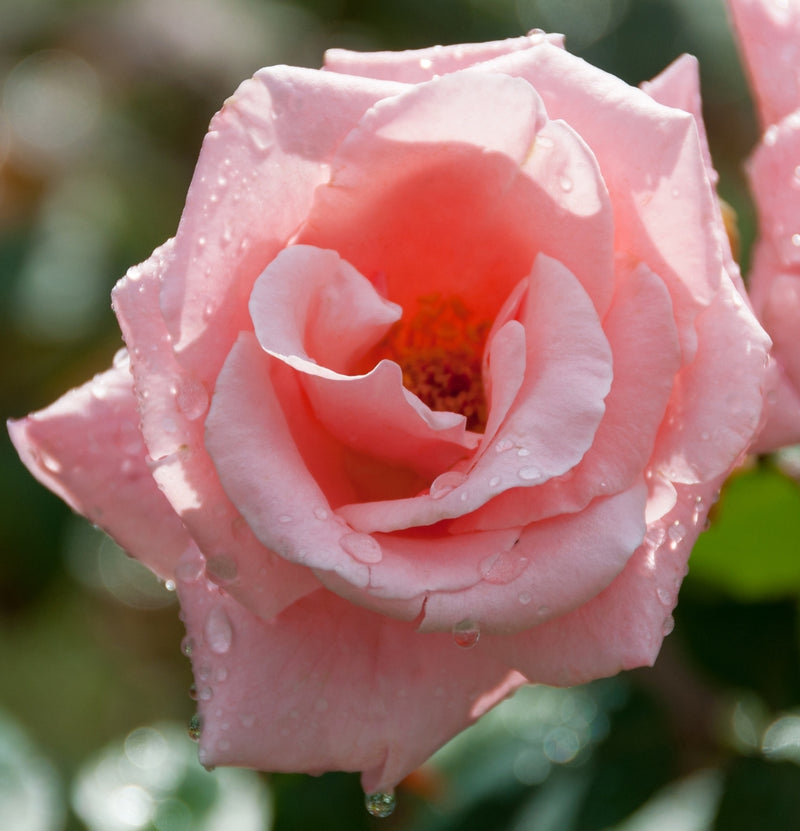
[379,293,491,432]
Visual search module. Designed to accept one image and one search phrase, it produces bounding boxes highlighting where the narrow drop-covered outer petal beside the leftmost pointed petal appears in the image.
[113,243,318,618]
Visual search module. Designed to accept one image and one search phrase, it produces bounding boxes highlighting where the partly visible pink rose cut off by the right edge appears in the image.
[729,0,800,450]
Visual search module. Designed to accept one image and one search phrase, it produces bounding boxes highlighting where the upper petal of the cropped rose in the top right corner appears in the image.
[728,0,800,127]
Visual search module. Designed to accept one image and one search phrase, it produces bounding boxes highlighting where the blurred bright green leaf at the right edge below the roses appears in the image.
[689,467,800,601]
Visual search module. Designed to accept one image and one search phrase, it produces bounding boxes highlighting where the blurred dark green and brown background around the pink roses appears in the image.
[0,0,800,831]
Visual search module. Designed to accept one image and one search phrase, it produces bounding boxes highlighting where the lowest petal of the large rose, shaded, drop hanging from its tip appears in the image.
[178,568,525,792]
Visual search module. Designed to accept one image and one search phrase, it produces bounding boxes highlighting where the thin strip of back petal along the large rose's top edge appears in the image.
[325,33,564,84]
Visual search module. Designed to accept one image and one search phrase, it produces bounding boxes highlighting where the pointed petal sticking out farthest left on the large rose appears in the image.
[8,358,191,579]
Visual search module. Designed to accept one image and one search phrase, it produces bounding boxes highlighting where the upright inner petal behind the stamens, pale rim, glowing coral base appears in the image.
[297,72,613,321]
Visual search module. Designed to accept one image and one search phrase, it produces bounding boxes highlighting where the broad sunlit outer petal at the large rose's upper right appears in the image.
[482,39,722,360]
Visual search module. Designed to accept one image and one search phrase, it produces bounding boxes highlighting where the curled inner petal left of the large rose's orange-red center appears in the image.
[250,245,477,478]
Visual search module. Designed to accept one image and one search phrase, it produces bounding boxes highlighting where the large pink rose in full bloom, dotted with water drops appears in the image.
[10,33,769,791]
